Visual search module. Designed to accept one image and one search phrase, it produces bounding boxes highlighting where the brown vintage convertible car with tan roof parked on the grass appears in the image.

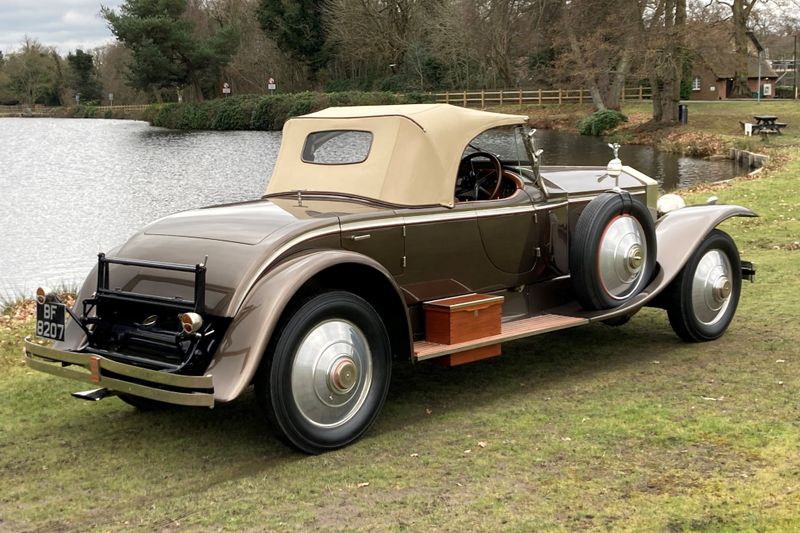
[25,104,755,453]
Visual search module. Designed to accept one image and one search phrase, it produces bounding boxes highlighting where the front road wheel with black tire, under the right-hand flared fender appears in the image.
[663,229,742,342]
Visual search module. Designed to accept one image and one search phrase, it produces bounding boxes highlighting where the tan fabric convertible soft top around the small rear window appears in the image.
[266,104,527,207]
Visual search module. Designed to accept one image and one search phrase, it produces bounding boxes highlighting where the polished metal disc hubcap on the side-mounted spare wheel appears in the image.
[597,215,647,300]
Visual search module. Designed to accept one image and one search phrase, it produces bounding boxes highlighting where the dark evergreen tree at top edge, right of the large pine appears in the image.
[256,0,329,80]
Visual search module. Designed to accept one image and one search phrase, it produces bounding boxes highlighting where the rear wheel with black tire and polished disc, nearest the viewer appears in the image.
[255,291,392,454]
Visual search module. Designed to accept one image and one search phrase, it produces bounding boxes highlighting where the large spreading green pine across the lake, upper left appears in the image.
[101,0,238,100]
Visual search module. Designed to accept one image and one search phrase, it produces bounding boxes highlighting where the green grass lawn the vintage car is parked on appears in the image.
[0,104,800,532]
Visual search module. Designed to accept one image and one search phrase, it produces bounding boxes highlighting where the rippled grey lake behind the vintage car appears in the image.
[0,118,741,301]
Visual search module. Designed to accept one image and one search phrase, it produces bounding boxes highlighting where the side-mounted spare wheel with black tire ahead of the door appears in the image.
[569,191,656,310]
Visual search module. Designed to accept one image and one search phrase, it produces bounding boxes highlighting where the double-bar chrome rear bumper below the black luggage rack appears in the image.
[25,337,214,407]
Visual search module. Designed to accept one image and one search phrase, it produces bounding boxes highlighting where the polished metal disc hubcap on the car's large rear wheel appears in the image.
[291,319,372,428]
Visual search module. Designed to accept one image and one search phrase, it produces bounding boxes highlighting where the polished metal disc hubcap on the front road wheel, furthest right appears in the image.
[692,250,733,325]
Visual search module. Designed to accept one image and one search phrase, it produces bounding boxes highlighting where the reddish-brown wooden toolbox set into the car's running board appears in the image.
[423,294,504,366]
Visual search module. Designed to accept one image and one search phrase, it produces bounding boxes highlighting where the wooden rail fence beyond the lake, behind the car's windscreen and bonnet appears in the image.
[433,87,651,108]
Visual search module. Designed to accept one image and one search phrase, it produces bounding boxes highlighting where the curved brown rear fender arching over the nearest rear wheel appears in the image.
[206,250,411,402]
